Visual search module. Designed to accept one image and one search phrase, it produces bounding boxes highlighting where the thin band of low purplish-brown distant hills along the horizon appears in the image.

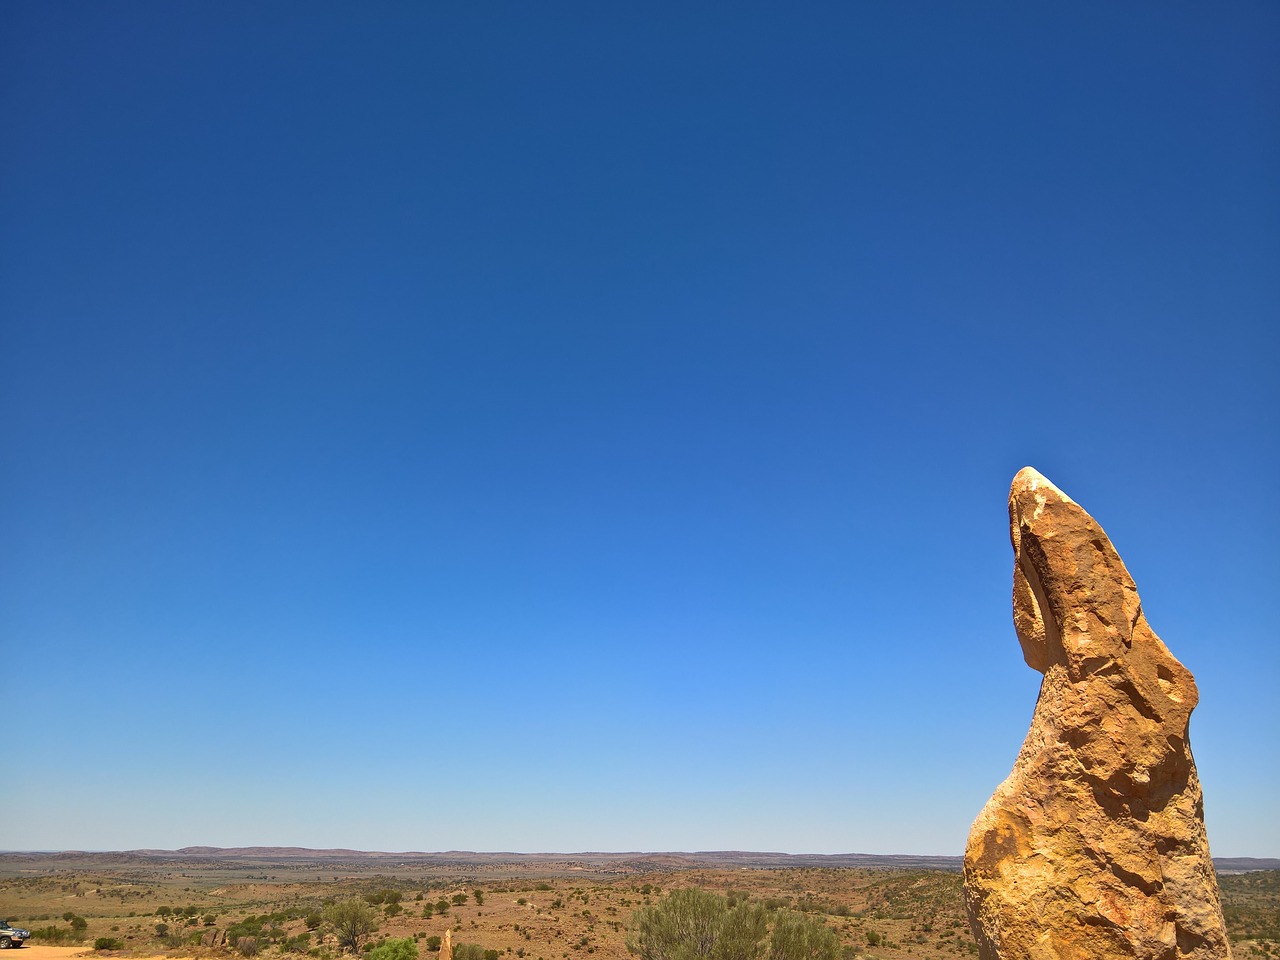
[0,846,1280,873]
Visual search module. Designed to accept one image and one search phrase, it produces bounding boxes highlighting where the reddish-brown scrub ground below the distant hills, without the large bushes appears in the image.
[0,867,1280,960]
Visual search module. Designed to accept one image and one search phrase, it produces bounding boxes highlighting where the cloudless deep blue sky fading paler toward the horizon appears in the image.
[0,0,1280,856]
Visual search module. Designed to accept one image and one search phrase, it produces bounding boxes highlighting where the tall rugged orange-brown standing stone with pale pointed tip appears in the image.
[964,467,1231,960]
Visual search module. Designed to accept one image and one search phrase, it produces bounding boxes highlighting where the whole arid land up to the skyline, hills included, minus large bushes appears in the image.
[0,849,1280,960]
